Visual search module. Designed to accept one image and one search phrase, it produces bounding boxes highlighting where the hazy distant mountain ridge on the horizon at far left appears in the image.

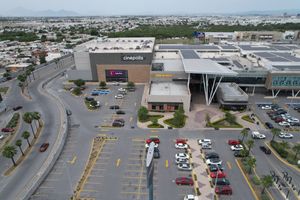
[2,7,80,17]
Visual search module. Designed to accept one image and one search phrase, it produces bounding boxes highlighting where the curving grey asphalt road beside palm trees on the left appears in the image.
[0,55,74,200]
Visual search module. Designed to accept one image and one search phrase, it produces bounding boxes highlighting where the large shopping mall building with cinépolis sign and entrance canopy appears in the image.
[68,37,300,111]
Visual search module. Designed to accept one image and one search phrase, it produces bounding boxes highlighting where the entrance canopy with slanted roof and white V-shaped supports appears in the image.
[180,50,237,105]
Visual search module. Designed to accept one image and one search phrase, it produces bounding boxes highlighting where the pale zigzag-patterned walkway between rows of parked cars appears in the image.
[188,140,214,200]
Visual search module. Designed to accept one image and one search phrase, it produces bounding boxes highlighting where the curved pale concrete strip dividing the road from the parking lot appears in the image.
[16,67,69,200]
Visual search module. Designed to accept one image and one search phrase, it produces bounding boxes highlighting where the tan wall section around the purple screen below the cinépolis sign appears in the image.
[97,64,151,83]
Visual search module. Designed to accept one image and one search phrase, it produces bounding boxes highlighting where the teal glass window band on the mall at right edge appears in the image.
[272,76,300,87]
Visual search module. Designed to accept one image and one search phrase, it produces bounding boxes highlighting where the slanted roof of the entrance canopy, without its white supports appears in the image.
[180,50,237,76]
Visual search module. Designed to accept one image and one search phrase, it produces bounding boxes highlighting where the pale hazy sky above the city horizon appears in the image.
[0,0,300,15]
